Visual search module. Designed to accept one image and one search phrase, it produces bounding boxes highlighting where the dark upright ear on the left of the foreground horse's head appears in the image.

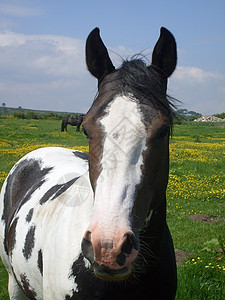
[86,28,115,80]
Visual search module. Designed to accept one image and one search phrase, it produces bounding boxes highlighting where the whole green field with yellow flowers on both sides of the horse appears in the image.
[0,119,225,300]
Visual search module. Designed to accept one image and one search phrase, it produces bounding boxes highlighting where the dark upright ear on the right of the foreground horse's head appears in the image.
[152,27,177,78]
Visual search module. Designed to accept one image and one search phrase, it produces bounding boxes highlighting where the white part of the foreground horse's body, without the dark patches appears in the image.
[0,147,93,300]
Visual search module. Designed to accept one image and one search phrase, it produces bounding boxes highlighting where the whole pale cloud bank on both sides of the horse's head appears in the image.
[0,31,225,114]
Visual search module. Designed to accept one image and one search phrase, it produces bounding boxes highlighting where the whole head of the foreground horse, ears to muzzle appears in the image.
[82,28,177,280]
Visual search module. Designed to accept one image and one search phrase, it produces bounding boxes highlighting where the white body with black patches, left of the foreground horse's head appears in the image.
[0,147,93,299]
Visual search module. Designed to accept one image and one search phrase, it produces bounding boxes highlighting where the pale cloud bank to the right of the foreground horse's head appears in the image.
[169,66,225,115]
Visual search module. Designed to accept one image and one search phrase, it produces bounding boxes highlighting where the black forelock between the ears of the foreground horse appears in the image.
[99,58,177,125]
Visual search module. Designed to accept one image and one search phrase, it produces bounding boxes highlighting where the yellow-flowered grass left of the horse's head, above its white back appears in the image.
[0,119,88,180]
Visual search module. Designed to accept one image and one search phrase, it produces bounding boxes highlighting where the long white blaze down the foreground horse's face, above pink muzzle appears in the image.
[91,96,147,236]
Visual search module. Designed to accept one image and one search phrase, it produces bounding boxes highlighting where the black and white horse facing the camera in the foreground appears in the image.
[0,27,177,300]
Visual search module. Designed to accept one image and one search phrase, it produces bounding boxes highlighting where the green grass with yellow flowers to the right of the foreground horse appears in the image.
[167,123,225,300]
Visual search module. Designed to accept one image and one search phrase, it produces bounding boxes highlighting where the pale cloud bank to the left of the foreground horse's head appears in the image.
[0,31,96,111]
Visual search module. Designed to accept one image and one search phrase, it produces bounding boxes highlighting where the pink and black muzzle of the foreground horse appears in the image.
[81,231,139,281]
